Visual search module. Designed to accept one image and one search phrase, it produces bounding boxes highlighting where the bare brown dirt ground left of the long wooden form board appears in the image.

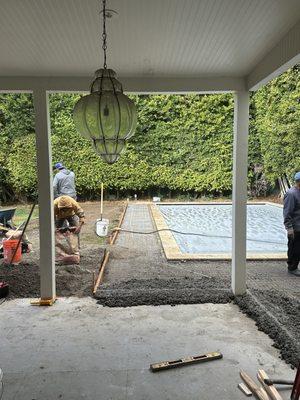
[0,201,124,299]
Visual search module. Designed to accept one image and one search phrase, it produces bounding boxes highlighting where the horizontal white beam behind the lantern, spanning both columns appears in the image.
[0,76,246,94]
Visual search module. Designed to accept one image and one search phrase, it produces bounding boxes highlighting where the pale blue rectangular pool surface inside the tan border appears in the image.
[159,204,287,254]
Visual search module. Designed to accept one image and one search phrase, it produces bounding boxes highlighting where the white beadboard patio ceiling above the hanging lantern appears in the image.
[0,0,300,89]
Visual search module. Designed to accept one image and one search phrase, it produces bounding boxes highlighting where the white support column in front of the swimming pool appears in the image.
[231,91,249,295]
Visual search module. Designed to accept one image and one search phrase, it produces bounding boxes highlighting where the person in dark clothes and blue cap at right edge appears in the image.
[283,171,300,276]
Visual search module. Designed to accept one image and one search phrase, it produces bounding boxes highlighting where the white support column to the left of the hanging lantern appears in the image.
[33,89,56,300]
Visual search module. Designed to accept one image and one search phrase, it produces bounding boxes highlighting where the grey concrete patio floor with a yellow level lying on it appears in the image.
[0,298,294,400]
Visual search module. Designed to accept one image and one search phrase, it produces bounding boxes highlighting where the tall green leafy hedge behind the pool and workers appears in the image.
[0,67,300,201]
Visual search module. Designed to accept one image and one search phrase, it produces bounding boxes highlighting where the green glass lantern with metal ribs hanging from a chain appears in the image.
[73,0,136,164]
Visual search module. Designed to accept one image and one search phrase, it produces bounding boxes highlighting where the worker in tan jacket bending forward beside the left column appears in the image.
[54,196,84,264]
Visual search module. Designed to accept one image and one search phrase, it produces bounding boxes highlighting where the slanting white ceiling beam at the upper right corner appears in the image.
[247,21,300,90]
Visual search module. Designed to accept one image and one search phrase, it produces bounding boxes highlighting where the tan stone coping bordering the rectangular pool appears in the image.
[150,201,287,261]
